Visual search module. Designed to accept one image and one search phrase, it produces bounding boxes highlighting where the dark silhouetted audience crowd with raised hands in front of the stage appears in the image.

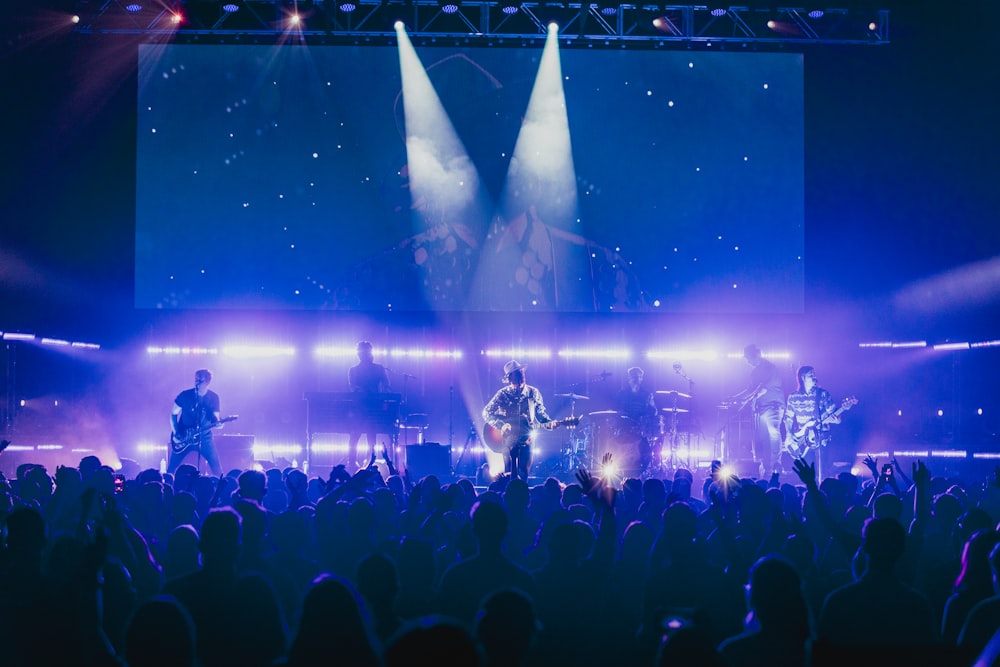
[0,444,1000,667]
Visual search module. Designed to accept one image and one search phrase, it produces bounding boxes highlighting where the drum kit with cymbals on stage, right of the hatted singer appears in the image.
[555,390,692,477]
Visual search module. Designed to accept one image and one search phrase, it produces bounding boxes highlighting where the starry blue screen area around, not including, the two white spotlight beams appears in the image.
[135,45,805,313]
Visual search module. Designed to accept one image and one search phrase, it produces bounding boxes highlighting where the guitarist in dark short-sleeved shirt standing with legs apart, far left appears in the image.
[167,368,222,476]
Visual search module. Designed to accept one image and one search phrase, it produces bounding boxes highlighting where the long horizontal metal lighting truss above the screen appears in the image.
[76,0,889,48]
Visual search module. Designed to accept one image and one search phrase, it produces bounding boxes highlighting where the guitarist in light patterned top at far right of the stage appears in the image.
[785,366,840,475]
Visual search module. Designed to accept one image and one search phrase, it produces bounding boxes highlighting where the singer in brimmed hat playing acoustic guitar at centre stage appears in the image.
[483,360,555,482]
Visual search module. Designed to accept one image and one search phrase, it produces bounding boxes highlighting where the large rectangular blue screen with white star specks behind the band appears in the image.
[135,40,804,313]
